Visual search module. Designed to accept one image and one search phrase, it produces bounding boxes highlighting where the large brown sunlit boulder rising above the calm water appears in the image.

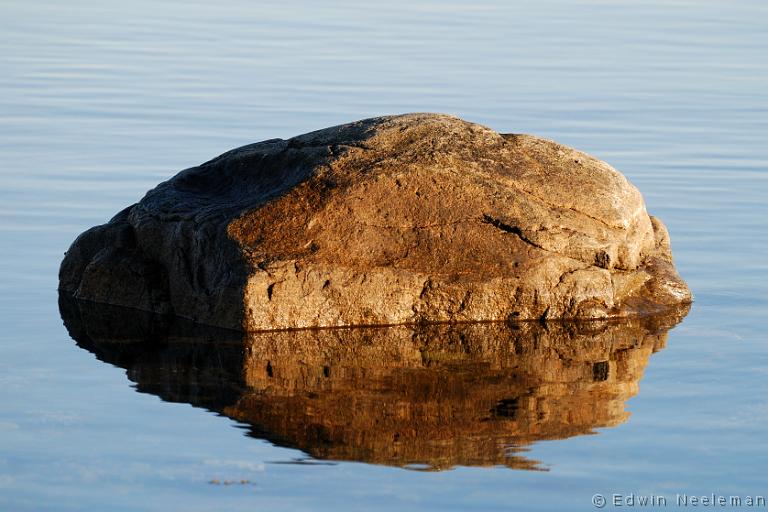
[60,114,691,330]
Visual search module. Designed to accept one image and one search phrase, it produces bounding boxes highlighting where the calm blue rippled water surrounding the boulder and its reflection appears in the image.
[0,0,768,511]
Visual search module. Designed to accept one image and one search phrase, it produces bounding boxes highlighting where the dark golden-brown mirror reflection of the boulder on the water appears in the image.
[61,299,685,469]
